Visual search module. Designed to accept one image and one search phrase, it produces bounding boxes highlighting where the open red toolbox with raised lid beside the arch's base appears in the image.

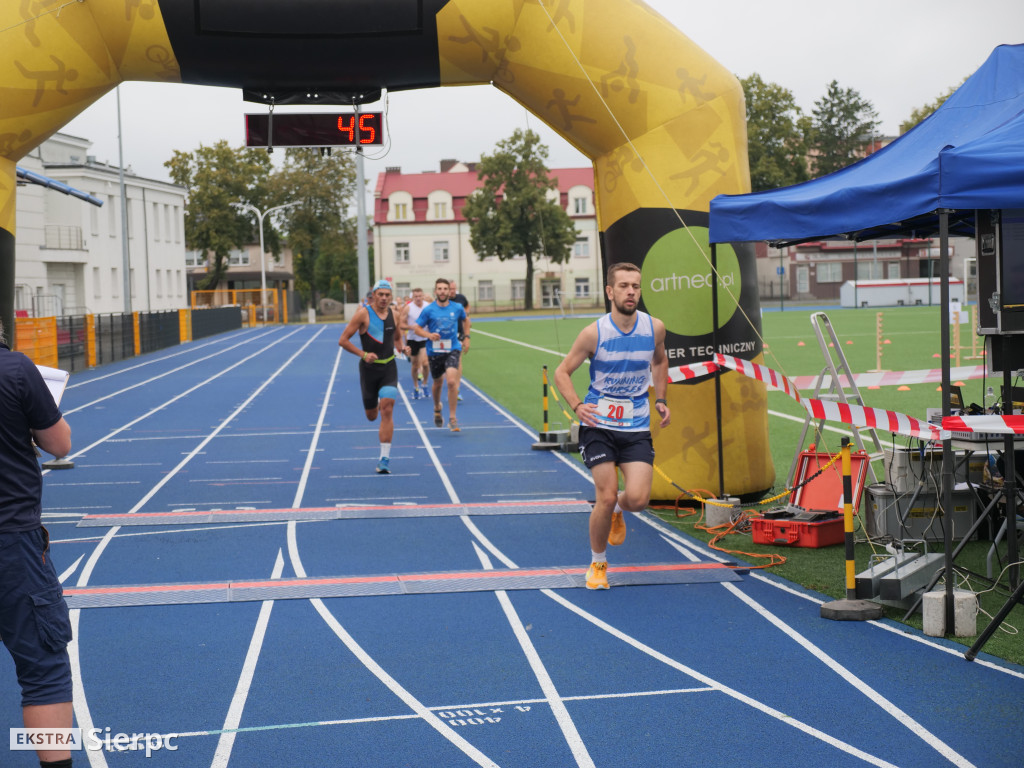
[751,445,867,549]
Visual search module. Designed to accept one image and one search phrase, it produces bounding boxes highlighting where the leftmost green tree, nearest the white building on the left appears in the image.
[164,140,276,289]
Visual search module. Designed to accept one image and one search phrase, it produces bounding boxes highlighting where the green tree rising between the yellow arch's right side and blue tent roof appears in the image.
[739,73,810,191]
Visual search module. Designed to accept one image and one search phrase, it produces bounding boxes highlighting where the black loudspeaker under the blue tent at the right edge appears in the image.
[975,208,1024,336]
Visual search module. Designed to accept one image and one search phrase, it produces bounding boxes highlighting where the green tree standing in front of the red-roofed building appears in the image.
[462,129,577,309]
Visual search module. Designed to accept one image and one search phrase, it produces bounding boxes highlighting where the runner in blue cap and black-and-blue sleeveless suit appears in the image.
[338,280,409,475]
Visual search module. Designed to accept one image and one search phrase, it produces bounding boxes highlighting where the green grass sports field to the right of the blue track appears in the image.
[464,306,1024,664]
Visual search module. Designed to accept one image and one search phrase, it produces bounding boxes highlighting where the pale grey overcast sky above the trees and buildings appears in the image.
[62,0,1024,189]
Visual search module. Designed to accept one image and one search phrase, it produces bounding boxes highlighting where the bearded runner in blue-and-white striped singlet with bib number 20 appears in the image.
[555,263,670,590]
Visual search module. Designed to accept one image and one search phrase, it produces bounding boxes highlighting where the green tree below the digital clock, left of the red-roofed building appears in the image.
[272,148,356,305]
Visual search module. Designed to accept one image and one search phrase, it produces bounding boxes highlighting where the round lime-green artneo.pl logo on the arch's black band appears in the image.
[641,226,740,336]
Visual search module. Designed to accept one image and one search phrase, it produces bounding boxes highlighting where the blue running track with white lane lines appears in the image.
[0,323,1024,768]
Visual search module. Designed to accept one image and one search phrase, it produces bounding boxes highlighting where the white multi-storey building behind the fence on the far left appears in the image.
[14,133,188,316]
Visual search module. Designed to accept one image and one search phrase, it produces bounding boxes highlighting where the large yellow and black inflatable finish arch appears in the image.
[0,0,774,499]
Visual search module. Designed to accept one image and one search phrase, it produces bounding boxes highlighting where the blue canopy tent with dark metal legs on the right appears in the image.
[709,45,1024,659]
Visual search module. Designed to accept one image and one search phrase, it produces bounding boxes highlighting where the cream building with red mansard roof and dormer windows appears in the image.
[374,160,604,311]
